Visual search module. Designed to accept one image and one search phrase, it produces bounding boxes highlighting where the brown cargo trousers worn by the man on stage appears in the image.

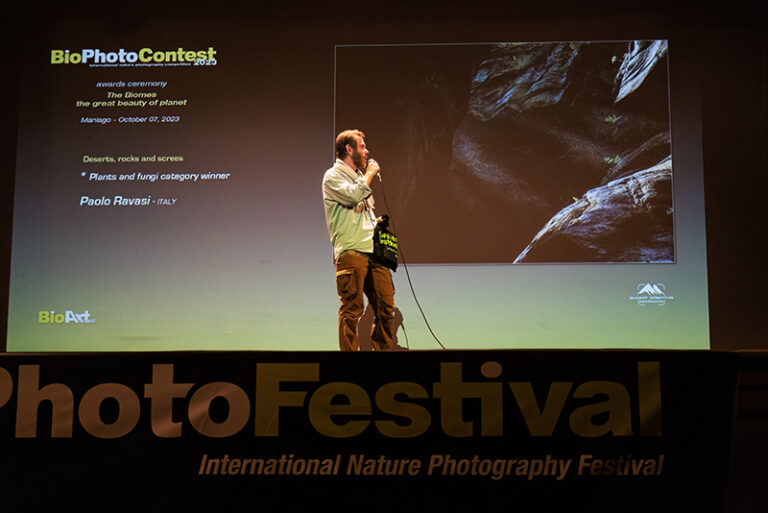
[336,251,396,351]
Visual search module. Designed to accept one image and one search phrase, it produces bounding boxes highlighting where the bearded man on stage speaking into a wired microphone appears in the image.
[323,130,402,351]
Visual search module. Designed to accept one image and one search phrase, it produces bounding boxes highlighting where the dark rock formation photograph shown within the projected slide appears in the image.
[336,40,675,263]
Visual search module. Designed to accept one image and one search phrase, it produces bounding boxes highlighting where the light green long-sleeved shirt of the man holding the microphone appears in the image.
[323,159,376,261]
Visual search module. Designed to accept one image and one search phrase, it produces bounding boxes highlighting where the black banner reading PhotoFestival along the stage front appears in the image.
[0,351,737,512]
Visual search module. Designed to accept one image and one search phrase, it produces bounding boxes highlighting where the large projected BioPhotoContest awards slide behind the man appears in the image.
[7,21,709,351]
